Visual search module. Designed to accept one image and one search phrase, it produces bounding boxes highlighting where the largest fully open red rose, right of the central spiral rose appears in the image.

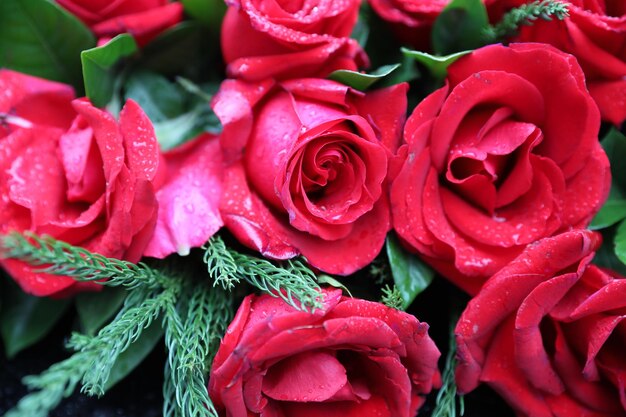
[391,44,611,294]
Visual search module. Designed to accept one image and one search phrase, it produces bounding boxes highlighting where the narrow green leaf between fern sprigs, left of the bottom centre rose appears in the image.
[105,320,163,391]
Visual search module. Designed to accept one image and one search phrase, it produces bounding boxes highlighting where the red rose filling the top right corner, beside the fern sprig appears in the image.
[519,0,626,125]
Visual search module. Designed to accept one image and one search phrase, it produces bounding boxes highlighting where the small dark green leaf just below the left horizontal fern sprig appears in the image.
[76,288,128,336]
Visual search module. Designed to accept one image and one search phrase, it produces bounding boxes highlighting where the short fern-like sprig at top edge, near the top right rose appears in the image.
[485,0,569,43]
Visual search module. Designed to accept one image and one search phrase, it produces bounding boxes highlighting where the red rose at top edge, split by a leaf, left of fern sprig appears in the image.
[369,0,524,51]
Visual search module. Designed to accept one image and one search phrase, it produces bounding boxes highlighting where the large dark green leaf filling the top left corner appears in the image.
[0,0,96,91]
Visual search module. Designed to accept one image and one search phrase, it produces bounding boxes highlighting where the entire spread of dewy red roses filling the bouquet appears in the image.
[0,0,626,417]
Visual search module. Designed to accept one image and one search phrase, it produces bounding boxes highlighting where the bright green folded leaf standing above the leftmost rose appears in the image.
[80,33,137,107]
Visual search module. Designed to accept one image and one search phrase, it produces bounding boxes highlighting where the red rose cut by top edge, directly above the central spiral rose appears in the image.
[221,0,368,80]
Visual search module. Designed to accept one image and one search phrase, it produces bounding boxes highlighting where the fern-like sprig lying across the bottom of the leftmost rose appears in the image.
[0,232,167,288]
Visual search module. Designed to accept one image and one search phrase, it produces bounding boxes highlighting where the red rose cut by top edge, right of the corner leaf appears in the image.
[57,0,183,45]
